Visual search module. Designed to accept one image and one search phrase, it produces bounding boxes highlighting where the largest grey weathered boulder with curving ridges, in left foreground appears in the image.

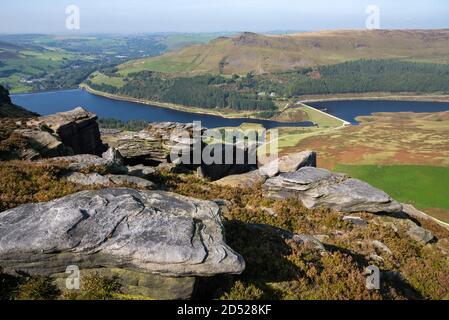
[0,189,245,277]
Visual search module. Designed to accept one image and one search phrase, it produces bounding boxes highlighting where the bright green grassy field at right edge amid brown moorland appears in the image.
[335,165,449,222]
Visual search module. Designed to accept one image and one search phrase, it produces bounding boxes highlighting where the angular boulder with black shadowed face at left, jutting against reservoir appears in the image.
[27,107,106,155]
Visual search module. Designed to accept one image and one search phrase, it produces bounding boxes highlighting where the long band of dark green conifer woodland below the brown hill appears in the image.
[88,60,449,113]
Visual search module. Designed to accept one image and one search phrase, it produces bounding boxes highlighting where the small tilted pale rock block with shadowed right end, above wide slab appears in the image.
[259,151,317,178]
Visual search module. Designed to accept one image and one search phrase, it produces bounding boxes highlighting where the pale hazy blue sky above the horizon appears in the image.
[0,0,449,33]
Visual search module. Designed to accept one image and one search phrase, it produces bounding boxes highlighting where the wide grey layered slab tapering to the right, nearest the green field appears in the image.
[264,167,402,213]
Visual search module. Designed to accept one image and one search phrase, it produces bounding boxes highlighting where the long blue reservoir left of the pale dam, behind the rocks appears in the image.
[11,89,313,129]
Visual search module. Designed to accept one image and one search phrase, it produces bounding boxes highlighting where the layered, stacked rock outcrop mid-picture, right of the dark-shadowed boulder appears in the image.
[102,122,201,166]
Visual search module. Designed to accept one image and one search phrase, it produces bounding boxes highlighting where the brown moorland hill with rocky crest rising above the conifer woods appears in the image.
[119,30,449,75]
